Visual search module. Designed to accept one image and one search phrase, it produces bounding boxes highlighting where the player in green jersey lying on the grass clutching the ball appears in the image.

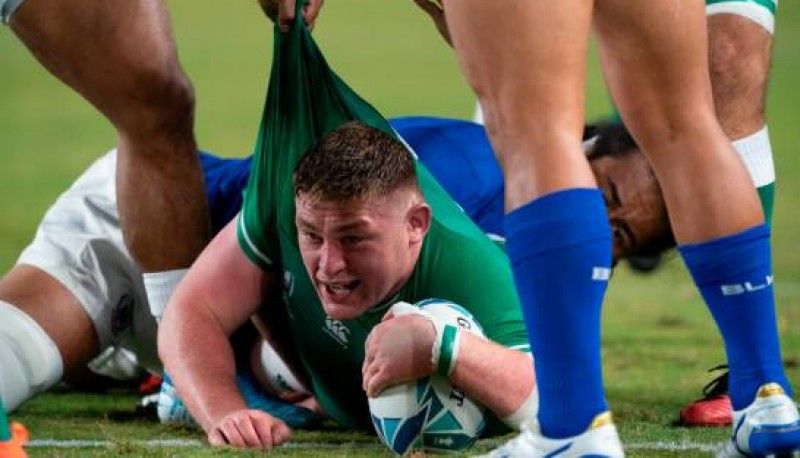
[159,123,535,448]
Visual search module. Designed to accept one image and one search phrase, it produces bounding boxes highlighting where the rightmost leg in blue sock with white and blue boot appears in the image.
[596,0,800,456]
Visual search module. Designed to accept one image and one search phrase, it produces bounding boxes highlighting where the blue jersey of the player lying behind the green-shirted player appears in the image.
[200,116,503,235]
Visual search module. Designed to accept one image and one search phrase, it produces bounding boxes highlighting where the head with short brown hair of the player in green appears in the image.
[294,125,432,320]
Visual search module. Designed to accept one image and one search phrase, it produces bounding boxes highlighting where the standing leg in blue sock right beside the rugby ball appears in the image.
[444,0,621,444]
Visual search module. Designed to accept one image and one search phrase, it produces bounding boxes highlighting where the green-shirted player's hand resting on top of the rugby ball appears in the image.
[361,307,436,397]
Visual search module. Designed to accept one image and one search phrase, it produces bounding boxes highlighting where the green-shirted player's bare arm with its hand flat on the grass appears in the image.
[158,219,290,448]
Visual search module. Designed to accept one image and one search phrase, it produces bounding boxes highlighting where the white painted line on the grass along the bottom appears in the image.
[25,439,719,452]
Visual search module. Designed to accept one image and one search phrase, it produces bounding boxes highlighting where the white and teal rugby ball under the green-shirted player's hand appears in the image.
[368,299,485,455]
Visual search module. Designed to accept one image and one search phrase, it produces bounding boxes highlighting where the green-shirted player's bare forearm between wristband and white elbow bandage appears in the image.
[450,332,535,418]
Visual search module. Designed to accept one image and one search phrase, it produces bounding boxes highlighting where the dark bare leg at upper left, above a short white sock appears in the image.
[11,0,209,272]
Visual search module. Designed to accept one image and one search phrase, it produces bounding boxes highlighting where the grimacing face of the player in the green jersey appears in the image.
[295,189,427,320]
